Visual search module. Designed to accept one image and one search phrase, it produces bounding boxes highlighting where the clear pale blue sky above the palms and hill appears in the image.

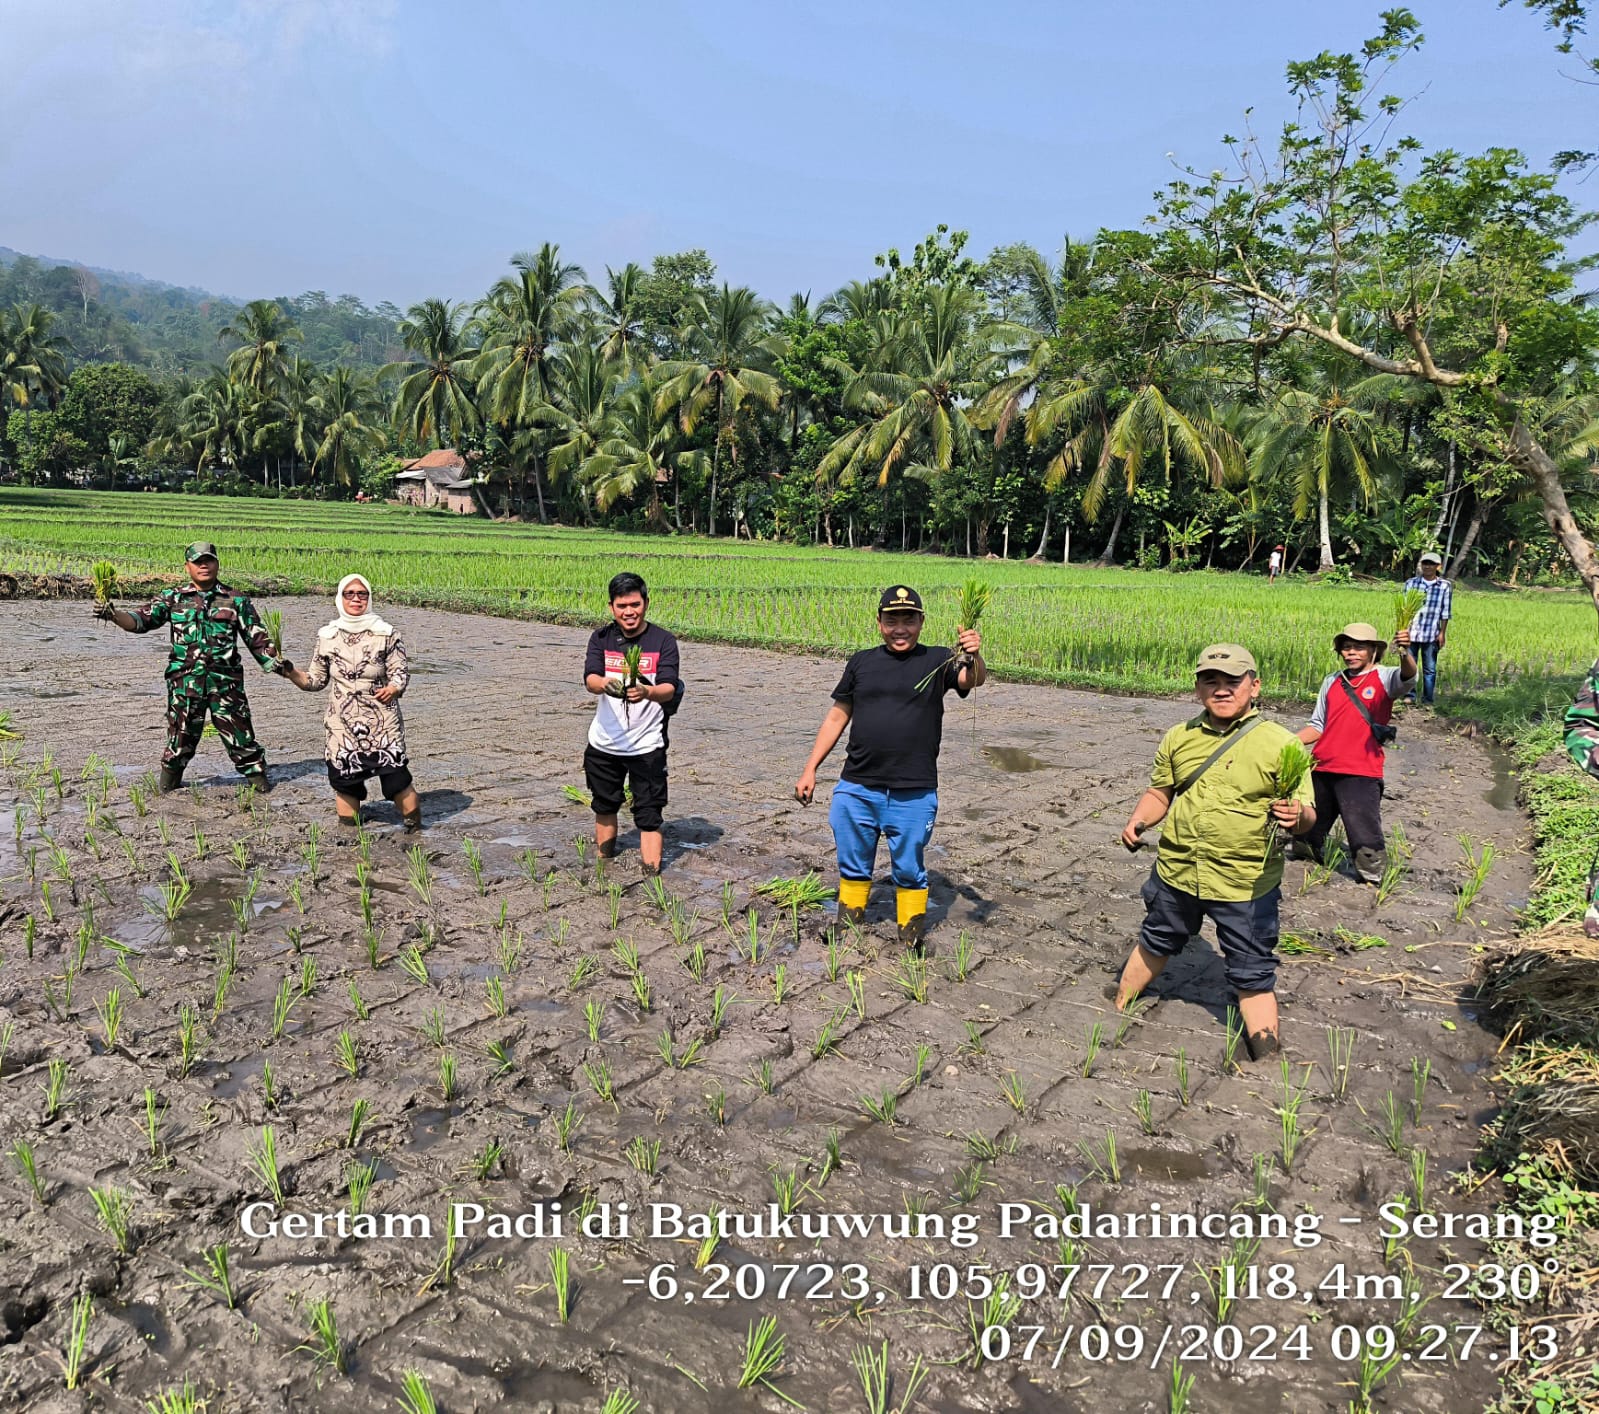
[0,0,1599,306]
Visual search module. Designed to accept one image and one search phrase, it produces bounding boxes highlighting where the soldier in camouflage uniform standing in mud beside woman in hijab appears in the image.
[94,541,293,790]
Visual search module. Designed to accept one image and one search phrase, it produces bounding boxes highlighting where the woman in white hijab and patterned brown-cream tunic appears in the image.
[285,574,422,830]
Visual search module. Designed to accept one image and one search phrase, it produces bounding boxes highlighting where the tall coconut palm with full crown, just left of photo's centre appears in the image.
[656,285,782,534]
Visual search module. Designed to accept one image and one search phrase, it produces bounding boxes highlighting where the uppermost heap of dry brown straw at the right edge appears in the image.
[1477,926,1599,1046]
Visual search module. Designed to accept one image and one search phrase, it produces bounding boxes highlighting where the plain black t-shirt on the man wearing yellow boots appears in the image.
[833,643,971,790]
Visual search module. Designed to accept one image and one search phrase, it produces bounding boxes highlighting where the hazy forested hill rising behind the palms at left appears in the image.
[0,246,403,376]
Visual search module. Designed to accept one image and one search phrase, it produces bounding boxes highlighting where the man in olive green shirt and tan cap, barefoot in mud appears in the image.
[1116,643,1316,1061]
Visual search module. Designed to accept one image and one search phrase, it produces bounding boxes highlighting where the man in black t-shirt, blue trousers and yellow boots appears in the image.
[795,585,988,949]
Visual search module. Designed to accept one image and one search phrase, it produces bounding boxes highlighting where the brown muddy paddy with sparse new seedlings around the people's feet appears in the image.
[0,600,1532,1414]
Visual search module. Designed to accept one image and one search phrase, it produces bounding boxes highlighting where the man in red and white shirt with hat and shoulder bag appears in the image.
[1298,624,1415,883]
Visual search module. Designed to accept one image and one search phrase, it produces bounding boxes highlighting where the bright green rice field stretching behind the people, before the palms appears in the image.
[0,489,1599,701]
